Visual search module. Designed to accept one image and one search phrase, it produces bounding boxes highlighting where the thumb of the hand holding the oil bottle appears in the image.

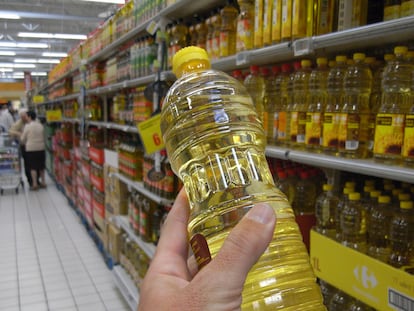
[205,203,276,287]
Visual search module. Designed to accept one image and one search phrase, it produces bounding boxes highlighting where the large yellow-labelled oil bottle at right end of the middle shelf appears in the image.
[374,46,414,164]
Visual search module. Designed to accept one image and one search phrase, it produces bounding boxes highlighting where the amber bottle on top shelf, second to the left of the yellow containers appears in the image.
[220,0,239,57]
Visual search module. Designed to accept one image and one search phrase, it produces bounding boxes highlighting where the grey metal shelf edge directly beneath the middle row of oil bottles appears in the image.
[266,146,414,183]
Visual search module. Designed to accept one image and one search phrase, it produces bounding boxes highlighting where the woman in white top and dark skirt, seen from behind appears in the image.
[21,110,46,190]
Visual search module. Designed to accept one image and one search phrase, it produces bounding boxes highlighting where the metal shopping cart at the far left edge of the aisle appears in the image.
[0,133,24,195]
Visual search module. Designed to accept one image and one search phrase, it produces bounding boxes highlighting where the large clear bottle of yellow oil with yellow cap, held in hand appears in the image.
[161,47,325,310]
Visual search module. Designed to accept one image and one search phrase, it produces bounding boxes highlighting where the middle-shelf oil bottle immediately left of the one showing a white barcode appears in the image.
[322,55,348,155]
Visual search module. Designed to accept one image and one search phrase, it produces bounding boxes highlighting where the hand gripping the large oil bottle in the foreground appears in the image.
[138,190,276,311]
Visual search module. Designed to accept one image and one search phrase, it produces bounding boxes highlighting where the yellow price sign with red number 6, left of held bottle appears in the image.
[137,114,164,154]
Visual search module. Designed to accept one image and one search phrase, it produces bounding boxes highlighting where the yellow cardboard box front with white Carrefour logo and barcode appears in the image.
[310,230,414,311]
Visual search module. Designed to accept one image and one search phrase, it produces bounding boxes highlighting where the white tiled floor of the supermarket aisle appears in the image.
[0,180,129,311]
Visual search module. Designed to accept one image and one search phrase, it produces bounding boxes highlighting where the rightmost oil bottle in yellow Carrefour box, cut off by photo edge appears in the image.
[388,201,414,268]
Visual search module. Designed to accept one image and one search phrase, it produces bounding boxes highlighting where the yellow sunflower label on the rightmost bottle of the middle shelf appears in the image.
[374,114,404,155]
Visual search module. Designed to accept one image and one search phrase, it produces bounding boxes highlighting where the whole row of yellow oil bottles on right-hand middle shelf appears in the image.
[238,46,414,165]
